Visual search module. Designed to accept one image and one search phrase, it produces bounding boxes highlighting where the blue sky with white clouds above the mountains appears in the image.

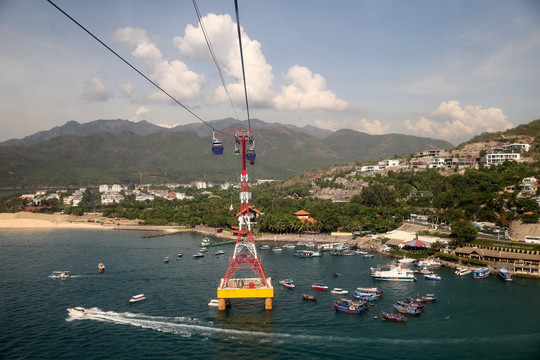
[0,0,540,145]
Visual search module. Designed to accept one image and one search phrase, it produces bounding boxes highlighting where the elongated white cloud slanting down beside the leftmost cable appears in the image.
[112,27,204,101]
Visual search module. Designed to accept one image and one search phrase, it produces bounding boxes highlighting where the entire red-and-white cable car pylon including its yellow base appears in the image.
[217,130,274,310]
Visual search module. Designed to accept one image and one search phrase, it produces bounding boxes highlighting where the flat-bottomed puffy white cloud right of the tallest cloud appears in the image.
[274,65,349,111]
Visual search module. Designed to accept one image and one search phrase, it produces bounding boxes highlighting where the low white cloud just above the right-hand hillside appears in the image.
[404,100,513,143]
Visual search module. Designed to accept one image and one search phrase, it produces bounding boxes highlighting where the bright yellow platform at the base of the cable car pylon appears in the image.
[217,278,274,299]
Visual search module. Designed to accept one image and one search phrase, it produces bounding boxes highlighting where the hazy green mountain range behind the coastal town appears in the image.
[0,118,454,188]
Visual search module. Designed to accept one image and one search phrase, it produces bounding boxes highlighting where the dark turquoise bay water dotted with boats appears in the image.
[0,230,540,359]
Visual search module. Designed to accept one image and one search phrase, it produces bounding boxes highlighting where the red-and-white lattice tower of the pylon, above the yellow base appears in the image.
[221,130,270,288]
